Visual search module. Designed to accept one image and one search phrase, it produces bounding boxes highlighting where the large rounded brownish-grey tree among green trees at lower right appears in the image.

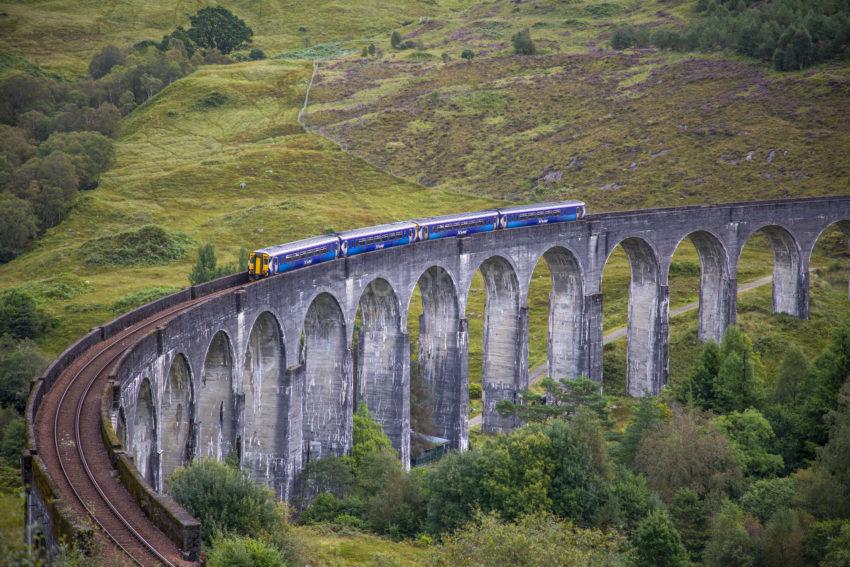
[635,409,741,502]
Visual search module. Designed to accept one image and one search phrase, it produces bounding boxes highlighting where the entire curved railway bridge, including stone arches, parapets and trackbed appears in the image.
[23,197,850,565]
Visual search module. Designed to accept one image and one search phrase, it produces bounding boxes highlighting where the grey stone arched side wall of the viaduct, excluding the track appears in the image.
[111,197,850,498]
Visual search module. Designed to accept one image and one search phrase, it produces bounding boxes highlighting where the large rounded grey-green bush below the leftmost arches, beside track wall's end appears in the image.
[168,460,280,543]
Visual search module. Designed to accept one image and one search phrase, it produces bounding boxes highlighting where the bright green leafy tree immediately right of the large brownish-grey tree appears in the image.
[715,408,785,477]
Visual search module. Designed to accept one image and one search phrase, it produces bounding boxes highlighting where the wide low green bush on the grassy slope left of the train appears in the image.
[82,224,192,266]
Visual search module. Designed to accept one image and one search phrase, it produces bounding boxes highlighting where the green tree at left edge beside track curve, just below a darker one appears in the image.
[0,338,48,412]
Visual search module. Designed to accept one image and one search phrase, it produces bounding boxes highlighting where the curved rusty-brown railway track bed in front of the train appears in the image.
[35,288,238,567]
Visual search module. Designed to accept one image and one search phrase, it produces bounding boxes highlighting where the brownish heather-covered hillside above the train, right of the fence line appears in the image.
[306,0,850,210]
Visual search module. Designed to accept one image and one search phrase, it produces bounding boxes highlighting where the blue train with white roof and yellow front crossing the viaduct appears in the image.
[248,201,585,279]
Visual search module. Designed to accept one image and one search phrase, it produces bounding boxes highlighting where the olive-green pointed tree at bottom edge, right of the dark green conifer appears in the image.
[703,500,755,567]
